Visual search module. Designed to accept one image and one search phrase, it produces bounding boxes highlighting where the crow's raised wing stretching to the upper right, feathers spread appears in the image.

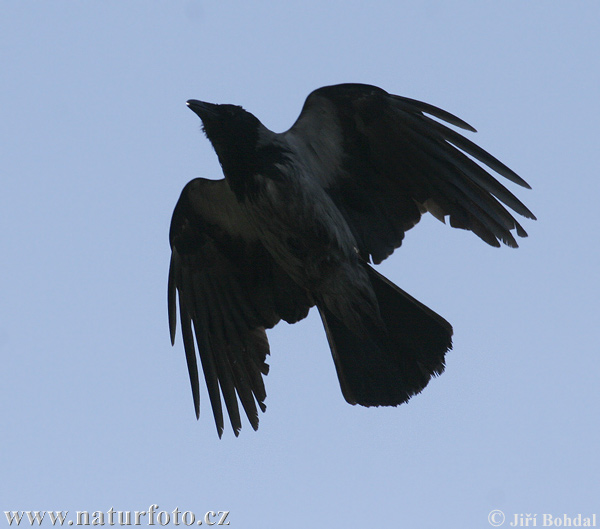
[283,84,535,263]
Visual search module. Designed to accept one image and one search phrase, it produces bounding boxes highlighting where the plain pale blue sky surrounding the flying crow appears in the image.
[0,0,600,529]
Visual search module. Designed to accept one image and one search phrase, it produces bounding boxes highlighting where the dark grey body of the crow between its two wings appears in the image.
[240,153,378,328]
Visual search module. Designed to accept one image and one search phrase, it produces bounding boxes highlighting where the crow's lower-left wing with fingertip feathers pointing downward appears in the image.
[168,178,312,436]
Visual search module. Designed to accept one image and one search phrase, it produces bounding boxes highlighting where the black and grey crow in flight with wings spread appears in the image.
[167,83,535,438]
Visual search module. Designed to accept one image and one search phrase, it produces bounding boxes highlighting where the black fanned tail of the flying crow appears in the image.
[318,264,452,406]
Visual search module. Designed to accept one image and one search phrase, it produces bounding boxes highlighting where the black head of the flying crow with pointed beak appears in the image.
[187,99,262,166]
